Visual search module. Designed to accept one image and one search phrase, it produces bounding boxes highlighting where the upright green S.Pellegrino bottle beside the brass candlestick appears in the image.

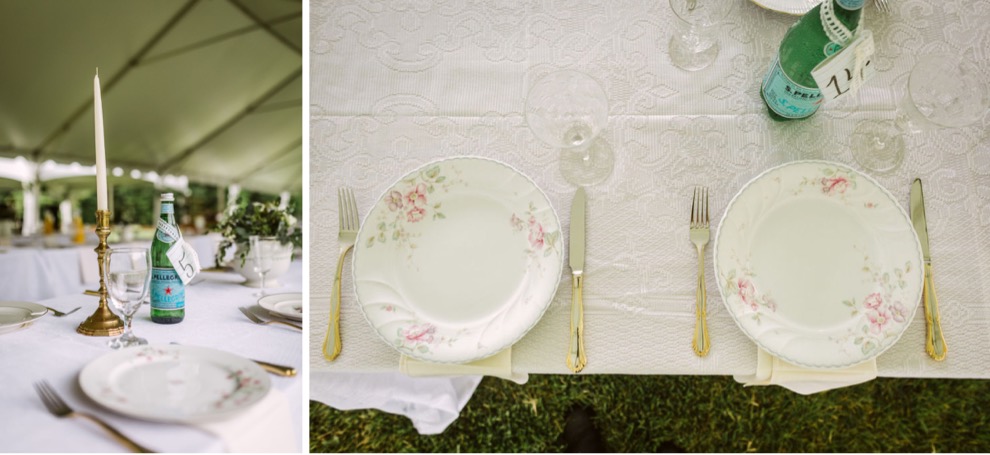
[151,193,186,324]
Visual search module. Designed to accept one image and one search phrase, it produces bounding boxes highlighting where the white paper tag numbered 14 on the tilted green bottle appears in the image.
[811,30,876,102]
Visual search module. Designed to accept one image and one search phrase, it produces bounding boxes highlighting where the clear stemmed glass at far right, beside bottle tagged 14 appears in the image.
[851,55,990,173]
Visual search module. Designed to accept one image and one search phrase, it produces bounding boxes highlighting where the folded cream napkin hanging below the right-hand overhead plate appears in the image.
[733,348,877,395]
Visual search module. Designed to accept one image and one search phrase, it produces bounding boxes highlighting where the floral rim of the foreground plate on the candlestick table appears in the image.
[78,344,272,423]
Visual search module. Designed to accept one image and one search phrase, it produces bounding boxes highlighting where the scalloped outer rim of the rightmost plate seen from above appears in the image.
[712,160,924,370]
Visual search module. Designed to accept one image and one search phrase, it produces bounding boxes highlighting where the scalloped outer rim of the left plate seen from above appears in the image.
[351,155,565,365]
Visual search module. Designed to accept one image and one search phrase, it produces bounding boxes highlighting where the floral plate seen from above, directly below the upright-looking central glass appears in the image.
[353,157,564,363]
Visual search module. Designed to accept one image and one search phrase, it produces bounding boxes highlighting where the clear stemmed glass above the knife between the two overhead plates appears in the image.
[526,70,615,186]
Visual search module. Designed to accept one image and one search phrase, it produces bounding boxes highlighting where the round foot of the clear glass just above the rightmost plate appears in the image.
[850,120,905,174]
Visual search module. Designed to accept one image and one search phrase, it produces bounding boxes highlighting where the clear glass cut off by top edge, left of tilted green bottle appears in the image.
[668,0,732,71]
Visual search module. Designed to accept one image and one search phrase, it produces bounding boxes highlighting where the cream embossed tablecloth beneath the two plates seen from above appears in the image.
[309,0,990,378]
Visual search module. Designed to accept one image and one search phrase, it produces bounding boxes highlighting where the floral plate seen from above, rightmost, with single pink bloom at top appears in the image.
[714,161,923,368]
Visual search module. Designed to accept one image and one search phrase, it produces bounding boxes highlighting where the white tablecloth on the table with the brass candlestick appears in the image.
[0,261,304,452]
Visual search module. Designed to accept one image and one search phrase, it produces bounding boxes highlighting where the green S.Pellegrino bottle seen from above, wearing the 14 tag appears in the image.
[760,0,865,121]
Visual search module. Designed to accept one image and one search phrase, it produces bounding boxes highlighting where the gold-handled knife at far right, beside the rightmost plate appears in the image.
[911,178,948,361]
